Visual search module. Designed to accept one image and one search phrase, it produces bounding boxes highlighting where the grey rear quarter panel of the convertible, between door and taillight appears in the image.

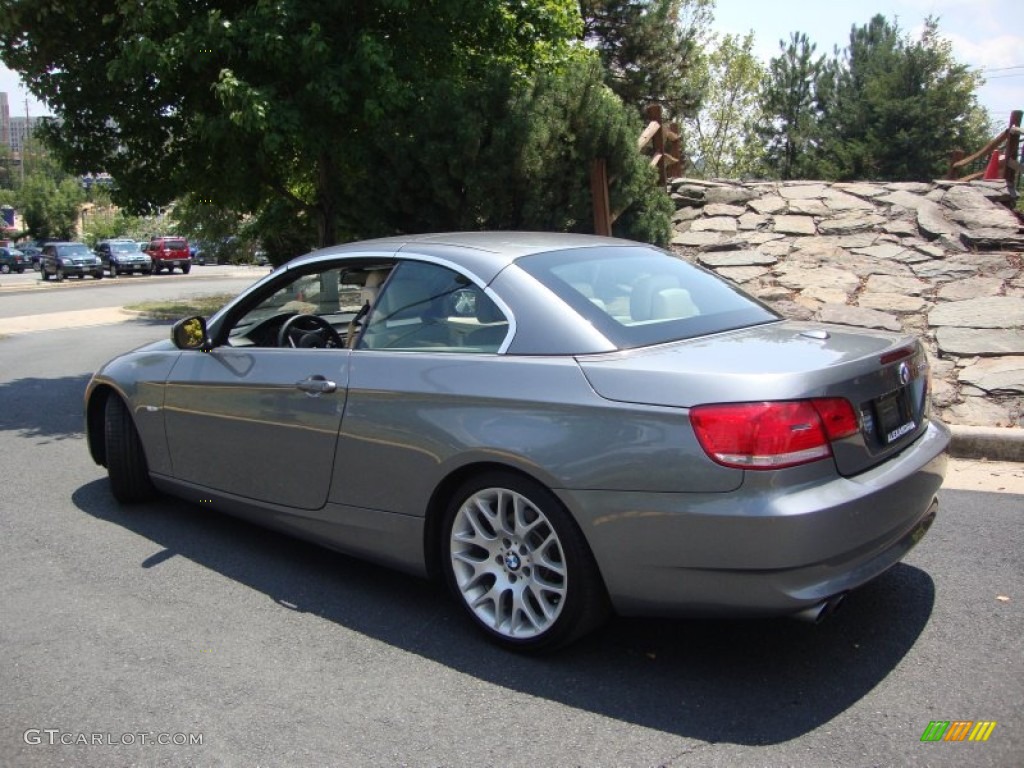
[331,350,742,515]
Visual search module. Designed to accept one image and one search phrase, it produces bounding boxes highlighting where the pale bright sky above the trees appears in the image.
[0,0,1024,124]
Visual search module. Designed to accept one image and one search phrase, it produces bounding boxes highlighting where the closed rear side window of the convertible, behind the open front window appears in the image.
[358,261,509,353]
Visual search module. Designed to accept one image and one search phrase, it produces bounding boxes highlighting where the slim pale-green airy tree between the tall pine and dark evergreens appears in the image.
[683,33,765,178]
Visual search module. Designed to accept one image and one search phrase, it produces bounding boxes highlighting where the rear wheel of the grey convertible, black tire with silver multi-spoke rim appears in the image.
[440,471,608,652]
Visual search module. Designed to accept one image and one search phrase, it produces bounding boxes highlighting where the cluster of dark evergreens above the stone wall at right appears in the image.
[760,15,989,180]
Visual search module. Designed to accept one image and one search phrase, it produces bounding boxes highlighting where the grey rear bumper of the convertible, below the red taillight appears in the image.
[559,422,949,615]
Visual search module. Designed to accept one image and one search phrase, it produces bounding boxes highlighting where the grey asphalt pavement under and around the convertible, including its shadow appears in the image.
[0,309,1024,768]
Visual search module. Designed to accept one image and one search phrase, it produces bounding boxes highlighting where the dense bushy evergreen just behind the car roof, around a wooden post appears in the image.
[359,55,671,243]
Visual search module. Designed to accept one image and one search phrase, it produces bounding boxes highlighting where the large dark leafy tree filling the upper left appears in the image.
[0,0,580,244]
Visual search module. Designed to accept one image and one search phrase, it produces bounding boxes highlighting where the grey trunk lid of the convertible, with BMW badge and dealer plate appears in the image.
[577,321,929,475]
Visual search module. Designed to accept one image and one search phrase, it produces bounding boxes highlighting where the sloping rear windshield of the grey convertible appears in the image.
[516,246,779,349]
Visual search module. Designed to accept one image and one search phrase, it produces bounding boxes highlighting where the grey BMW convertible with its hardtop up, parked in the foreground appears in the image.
[86,232,949,650]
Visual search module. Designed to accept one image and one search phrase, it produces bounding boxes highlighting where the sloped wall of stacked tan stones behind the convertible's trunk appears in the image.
[671,178,1024,427]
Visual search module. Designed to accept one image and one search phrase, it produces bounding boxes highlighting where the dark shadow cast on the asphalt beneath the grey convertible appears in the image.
[73,480,935,744]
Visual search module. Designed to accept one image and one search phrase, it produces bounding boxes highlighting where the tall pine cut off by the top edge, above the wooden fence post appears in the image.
[580,0,714,118]
